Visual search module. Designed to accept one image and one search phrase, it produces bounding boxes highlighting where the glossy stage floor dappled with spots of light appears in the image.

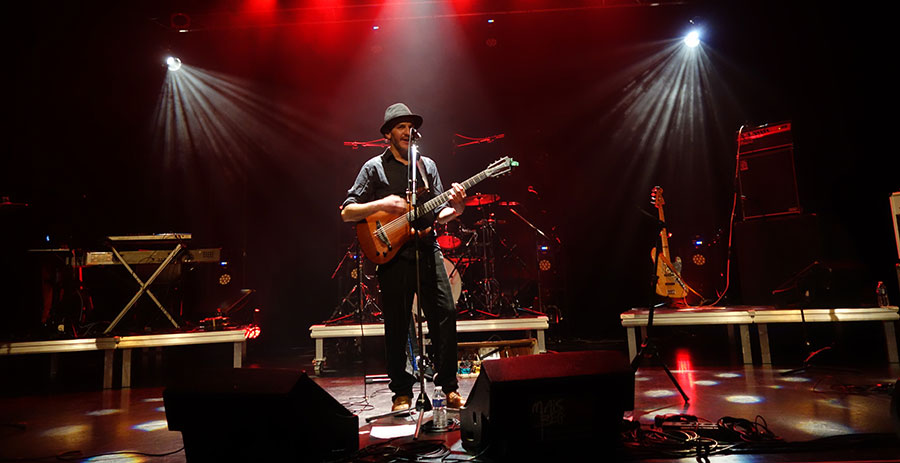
[0,354,900,462]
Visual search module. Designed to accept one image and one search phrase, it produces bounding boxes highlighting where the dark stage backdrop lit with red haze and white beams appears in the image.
[0,1,900,347]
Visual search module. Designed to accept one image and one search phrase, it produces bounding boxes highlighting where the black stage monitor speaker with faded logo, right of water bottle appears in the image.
[460,351,634,458]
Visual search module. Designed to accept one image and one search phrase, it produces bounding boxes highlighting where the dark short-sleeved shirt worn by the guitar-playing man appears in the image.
[342,149,447,254]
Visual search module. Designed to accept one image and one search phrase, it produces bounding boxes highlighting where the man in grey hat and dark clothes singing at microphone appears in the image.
[341,103,466,411]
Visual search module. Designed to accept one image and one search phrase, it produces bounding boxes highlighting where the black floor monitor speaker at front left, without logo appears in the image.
[163,368,359,463]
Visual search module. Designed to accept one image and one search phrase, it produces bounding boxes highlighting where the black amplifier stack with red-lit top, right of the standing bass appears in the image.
[738,122,802,220]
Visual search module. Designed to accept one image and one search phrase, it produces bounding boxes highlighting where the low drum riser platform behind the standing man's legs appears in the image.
[309,315,550,374]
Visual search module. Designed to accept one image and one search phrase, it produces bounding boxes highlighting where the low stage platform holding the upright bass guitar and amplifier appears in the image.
[620,306,900,365]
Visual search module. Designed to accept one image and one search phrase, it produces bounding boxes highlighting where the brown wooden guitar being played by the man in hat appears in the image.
[356,156,519,264]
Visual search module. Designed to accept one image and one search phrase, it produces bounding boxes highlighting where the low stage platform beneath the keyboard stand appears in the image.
[0,328,247,389]
